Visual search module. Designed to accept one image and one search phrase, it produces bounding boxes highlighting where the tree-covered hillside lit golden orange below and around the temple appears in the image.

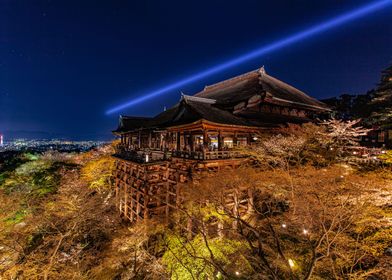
[0,130,392,279]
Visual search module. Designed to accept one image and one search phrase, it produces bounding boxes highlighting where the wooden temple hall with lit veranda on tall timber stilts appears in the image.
[113,68,329,222]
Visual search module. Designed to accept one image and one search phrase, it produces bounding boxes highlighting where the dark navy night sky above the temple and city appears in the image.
[0,0,392,139]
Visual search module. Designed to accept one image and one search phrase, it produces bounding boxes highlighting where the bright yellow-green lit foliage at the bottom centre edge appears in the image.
[162,234,251,279]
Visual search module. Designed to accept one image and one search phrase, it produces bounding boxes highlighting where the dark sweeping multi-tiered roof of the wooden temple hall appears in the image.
[114,68,328,133]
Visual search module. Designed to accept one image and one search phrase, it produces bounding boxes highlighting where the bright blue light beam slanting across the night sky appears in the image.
[106,0,392,115]
